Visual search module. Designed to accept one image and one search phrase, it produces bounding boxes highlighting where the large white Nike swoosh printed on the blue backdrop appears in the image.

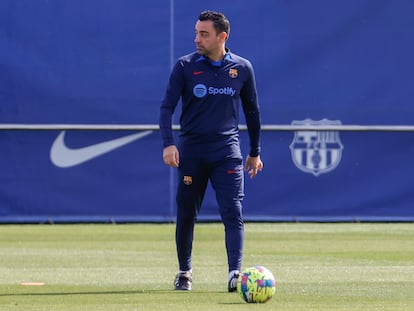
[50,131,153,168]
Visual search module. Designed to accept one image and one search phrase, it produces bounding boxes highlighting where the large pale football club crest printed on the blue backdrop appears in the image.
[290,119,344,176]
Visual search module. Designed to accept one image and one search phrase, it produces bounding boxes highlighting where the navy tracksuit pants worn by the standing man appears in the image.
[175,157,244,271]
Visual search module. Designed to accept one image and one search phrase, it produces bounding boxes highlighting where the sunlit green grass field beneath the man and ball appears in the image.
[0,223,414,311]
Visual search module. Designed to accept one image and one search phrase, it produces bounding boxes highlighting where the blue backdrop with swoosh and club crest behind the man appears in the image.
[0,0,414,222]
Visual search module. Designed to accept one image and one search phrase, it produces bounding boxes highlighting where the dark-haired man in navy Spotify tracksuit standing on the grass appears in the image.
[160,11,263,292]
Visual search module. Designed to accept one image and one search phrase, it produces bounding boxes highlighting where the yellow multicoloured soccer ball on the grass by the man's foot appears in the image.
[237,266,276,303]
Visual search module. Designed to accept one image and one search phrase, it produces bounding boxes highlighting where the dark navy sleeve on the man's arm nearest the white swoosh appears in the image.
[159,61,184,148]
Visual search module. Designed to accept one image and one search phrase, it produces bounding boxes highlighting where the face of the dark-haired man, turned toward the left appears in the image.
[194,21,227,57]
